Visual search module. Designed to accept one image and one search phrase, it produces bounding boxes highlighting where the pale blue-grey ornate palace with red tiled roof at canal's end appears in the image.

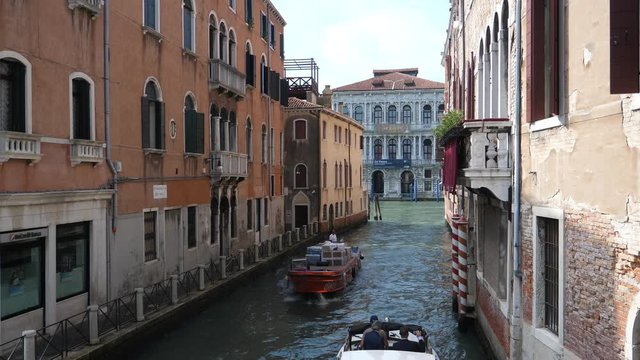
[324,68,444,199]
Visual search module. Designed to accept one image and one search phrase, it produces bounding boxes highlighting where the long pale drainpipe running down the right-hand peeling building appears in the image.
[510,0,522,360]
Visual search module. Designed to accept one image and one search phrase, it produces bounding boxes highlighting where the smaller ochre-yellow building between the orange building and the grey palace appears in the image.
[285,97,368,233]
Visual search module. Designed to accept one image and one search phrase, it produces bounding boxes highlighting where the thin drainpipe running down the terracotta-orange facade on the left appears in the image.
[103,0,118,300]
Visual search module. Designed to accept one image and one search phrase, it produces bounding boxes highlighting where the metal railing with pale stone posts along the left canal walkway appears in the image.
[0,232,312,360]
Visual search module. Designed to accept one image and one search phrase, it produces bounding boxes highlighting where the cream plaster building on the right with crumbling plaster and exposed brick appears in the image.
[442,0,640,359]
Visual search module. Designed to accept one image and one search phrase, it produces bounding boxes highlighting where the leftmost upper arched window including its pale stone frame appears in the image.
[0,55,31,133]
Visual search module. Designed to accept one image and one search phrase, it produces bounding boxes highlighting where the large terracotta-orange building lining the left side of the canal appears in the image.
[0,0,287,342]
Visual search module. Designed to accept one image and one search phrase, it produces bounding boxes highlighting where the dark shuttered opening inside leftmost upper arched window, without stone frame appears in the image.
[0,58,26,132]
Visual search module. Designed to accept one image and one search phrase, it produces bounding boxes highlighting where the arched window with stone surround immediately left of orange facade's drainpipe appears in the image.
[70,73,95,140]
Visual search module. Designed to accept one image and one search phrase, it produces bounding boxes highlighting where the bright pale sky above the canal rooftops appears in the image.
[271,0,449,92]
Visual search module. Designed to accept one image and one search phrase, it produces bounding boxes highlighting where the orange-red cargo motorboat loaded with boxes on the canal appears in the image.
[289,241,363,294]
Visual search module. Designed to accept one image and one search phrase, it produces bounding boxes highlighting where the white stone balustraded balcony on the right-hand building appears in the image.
[461,119,512,201]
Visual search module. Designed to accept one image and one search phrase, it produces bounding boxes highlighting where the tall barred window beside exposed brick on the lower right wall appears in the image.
[538,217,560,335]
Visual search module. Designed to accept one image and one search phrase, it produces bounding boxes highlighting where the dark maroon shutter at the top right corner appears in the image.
[609,0,640,94]
